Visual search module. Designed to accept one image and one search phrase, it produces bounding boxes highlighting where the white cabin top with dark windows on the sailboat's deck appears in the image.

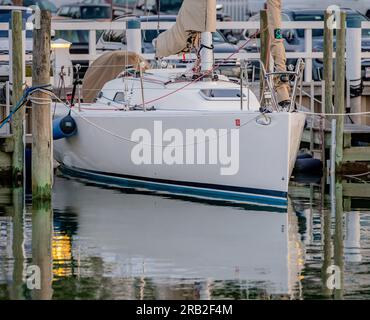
[93,69,260,111]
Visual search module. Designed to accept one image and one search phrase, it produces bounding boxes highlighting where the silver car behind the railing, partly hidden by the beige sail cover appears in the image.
[96,15,243,76]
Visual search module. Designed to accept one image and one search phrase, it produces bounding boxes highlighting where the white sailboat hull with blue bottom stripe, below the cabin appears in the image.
[54,110,305,206]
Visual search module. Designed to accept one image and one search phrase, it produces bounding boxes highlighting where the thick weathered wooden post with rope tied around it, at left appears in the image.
[32,10,53,200]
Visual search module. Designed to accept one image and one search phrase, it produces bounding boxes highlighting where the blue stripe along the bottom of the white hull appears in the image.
[60,165,288,208]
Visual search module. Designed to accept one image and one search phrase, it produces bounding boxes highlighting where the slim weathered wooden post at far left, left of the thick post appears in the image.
[11,10,25,186]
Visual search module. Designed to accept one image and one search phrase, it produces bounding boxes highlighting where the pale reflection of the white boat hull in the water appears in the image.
[53,174,304,299]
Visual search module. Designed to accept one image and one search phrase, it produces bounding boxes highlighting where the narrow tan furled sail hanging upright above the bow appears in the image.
[267,0,290,102]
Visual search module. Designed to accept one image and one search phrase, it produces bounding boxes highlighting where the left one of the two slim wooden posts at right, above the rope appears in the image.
[324,11,333,119]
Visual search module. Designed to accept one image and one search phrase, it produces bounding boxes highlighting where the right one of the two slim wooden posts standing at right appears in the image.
[332,12,347,171]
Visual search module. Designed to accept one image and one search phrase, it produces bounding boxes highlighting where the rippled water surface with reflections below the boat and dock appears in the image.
[0,177,370,299]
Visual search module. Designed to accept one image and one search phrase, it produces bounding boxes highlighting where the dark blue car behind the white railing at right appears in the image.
[239,8,370,81]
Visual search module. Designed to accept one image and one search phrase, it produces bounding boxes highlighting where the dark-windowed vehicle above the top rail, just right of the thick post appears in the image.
[57,3,112,20]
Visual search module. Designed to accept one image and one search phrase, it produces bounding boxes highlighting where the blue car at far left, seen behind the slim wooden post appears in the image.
[0,6,33,81]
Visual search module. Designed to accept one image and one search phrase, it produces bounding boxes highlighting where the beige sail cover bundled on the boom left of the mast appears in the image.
[155,0,216,57]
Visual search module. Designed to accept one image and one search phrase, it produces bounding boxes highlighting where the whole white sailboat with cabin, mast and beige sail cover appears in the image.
[54,0,305,207]
